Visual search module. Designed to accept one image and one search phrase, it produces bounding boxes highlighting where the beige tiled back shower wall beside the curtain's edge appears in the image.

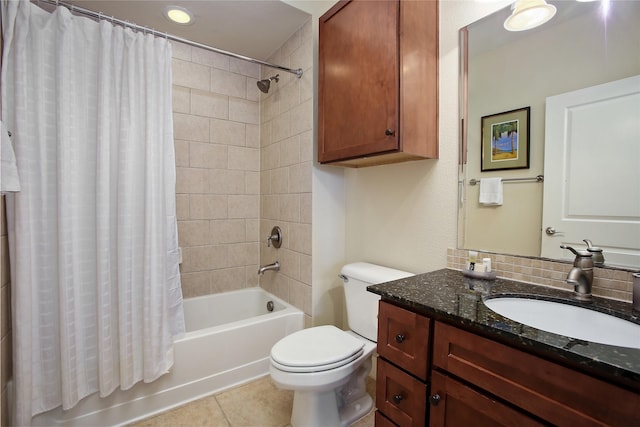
[173,43,260,297]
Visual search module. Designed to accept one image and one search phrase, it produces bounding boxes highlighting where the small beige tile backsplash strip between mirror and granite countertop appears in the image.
[447,248,633,302]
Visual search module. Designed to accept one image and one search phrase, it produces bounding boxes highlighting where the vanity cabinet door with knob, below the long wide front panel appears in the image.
[429,371,544,427]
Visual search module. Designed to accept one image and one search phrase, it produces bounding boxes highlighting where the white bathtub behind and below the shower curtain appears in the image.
[32,288,304,426]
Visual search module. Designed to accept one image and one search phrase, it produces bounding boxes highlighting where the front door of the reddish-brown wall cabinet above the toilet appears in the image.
[318,0,400,163]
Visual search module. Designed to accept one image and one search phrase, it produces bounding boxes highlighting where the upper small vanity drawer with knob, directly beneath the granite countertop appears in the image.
[378,301,431,381]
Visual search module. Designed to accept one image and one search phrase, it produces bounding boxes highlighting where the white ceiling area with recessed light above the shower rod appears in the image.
[66,0,310,60]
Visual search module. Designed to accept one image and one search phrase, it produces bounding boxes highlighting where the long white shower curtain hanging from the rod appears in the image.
[2,0,184,425]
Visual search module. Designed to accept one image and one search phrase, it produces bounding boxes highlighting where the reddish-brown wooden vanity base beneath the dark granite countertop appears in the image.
[376,301,640,427]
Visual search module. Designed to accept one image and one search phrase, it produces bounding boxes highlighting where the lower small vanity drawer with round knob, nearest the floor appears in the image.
[376,358,427,427]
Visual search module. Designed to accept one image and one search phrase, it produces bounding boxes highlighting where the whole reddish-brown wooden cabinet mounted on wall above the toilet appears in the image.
[318,0,438,167]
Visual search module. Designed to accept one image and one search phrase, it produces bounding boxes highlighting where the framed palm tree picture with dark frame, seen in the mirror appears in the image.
[480,107,531,171]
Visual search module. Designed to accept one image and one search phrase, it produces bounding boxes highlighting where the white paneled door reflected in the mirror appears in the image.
[541,76,640,267]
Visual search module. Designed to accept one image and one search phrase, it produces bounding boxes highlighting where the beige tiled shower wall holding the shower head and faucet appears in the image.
[253,20,313,326]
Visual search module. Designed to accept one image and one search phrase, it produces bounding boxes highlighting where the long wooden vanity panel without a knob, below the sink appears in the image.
[433,322,640,426]
